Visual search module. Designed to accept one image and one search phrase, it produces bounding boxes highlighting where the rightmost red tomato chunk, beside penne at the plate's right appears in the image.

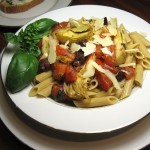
[122,66,135,80]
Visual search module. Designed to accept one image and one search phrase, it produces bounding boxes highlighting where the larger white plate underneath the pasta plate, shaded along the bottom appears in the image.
[0,77,150,150]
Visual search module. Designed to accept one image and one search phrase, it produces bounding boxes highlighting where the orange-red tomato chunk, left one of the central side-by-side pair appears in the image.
[52,62,67,81]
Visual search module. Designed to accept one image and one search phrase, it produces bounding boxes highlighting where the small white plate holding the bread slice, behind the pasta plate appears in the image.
[0,0,72,27]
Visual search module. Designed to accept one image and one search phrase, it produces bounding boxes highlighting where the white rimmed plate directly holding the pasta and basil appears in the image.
[1,5,150,134]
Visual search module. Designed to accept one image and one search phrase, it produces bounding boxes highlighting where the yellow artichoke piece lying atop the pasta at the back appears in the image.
[55,28,93,44]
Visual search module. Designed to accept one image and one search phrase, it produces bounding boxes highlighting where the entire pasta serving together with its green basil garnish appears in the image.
[5,17,150,107]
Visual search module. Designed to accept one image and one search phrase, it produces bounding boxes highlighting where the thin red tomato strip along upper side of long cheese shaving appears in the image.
[96,59,119,74]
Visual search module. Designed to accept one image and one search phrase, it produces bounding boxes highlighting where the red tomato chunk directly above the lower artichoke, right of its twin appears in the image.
[65,65,77,84]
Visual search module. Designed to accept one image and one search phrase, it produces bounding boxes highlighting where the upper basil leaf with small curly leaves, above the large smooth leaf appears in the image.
[4,18,57,57]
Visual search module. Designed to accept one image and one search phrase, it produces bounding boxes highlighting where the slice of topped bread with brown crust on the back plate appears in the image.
[0,0,44,13]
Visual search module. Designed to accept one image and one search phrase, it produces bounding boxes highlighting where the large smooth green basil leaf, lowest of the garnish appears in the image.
[5,50,38,93]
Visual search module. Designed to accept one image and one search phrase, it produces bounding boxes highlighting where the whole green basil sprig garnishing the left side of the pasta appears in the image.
[4,18,57,93]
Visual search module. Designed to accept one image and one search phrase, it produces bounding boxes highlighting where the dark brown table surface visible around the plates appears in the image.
[0,0,150,150]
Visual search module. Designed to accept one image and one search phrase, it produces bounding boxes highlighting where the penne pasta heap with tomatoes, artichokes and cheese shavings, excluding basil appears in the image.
[29,17,150,107]
